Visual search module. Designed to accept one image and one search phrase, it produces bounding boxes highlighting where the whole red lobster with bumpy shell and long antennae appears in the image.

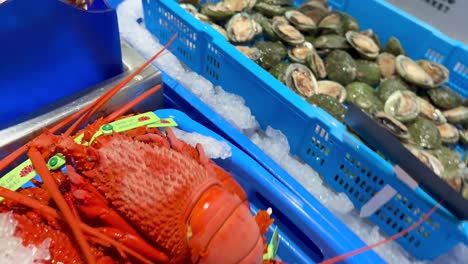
[0,36,273,263]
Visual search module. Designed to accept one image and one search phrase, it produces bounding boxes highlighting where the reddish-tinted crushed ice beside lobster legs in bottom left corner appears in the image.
[0,213,50,264]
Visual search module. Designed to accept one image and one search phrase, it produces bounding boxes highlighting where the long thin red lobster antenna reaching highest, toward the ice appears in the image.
[64,33,177,136]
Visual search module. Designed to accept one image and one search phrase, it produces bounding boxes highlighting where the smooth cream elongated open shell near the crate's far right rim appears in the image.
[395,55,434,88]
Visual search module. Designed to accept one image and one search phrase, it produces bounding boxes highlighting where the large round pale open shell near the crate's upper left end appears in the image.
[226,13,262,43]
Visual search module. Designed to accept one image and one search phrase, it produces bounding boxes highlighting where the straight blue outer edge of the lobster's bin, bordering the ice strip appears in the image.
[163,74,383,263]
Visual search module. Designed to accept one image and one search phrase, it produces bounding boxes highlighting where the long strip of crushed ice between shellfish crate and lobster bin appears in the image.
[117,0,468,264]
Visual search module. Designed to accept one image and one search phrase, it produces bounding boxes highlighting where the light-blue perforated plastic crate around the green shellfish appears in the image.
[143,0,468,259]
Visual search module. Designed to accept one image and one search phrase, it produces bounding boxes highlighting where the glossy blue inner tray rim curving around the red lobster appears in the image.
[11,106,383,263]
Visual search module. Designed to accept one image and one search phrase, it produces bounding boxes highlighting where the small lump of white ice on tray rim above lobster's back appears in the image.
[172,127,232,159]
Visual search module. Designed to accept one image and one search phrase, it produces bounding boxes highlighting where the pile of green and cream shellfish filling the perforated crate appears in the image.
[179,0,468,199]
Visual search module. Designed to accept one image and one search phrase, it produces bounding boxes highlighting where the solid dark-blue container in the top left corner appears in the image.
[0,0,123,128]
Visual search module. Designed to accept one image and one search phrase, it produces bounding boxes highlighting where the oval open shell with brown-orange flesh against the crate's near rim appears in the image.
[285,63,318,98]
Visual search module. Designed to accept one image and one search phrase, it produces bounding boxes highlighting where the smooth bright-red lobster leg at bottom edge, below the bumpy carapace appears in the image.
[98,227,169,263]
